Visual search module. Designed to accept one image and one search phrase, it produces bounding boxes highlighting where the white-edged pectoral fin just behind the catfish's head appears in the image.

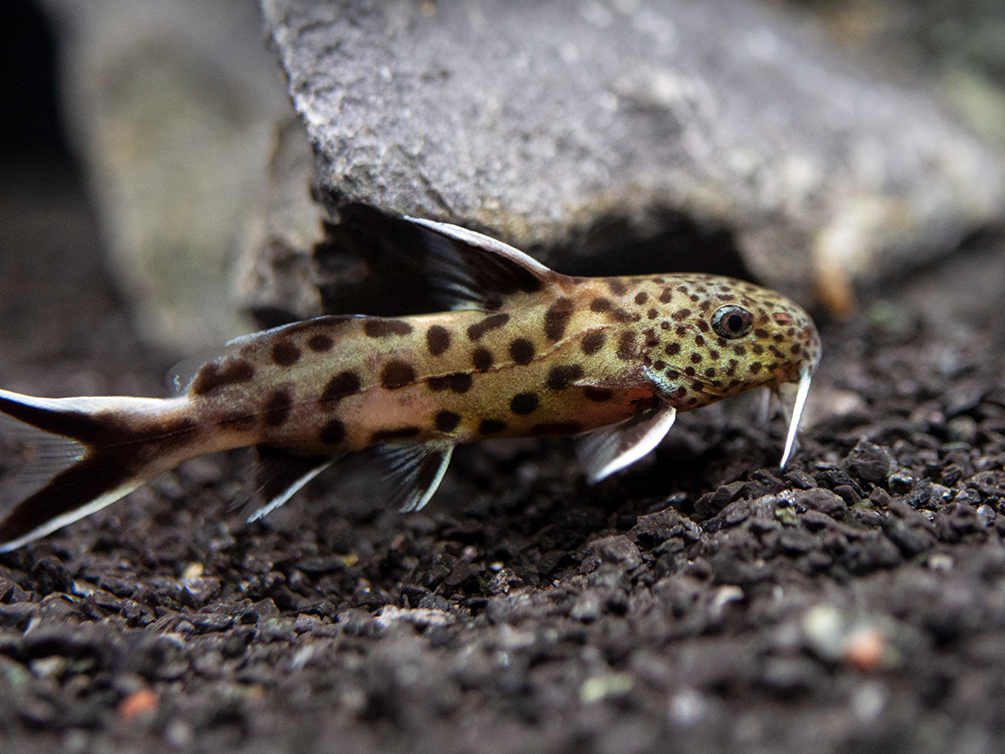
[576,404,677,485]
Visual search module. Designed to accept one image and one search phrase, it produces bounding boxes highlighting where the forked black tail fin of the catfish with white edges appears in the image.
[0,390,202,552]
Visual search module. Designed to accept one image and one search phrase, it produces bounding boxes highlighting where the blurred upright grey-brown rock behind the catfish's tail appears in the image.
[44,0,293,351]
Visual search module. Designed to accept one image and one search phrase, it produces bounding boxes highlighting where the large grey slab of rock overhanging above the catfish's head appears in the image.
[262,0,1005,310]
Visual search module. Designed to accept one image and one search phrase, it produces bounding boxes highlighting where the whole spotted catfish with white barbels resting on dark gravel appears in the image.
[0,220,820,551]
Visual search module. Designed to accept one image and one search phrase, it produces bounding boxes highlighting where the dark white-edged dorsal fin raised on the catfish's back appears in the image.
[405,217,559,312]
